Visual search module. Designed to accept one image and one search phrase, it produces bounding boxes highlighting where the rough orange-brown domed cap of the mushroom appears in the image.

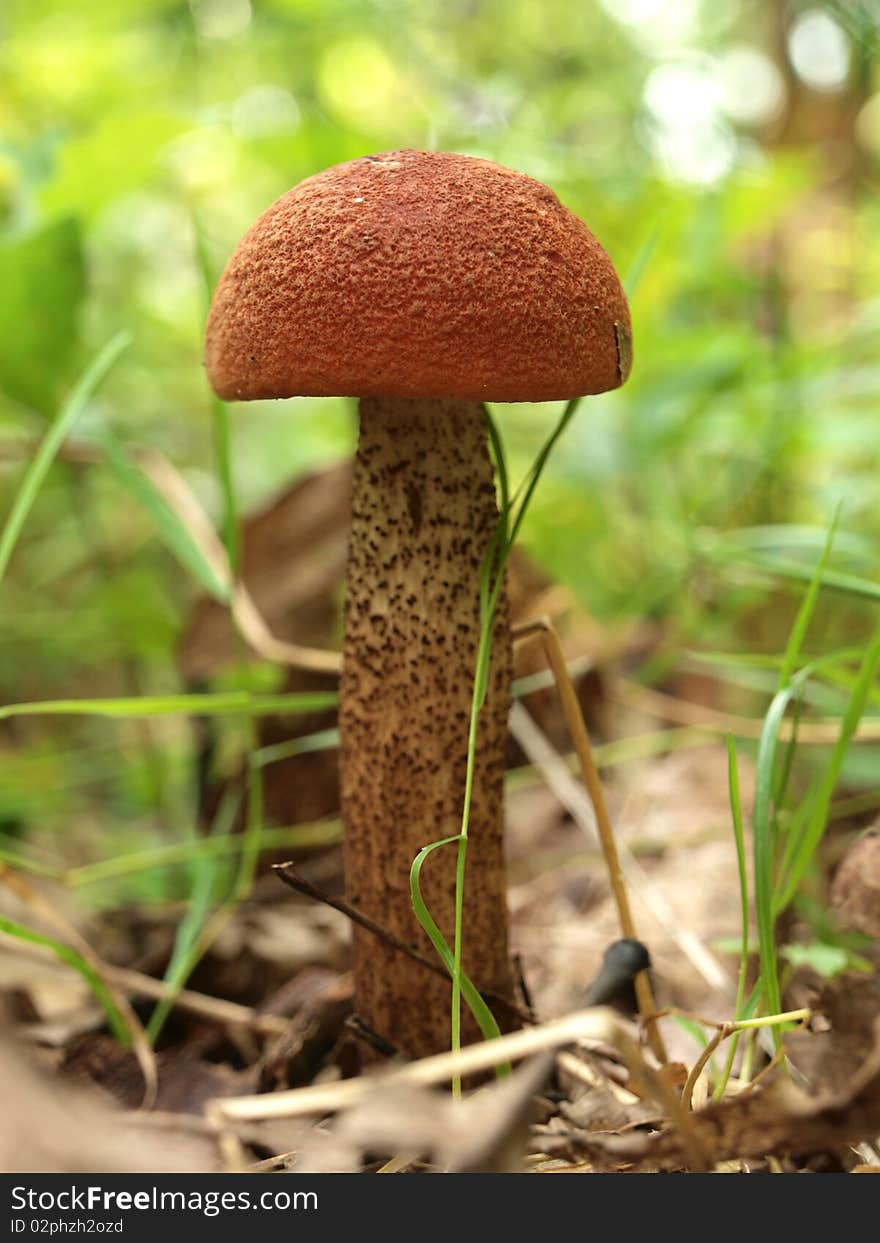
[206,150,630,401]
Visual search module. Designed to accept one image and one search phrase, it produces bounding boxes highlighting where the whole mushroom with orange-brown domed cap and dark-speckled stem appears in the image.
[206,150,629,1057]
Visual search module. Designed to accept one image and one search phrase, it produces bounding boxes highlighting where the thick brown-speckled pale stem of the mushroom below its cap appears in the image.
[339,398,512,1057]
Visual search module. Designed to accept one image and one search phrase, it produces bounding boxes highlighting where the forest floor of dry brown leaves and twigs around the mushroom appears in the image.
[0,742,880,1172]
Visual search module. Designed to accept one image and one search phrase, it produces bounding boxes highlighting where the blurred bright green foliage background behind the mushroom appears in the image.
[0,0,880,924]
